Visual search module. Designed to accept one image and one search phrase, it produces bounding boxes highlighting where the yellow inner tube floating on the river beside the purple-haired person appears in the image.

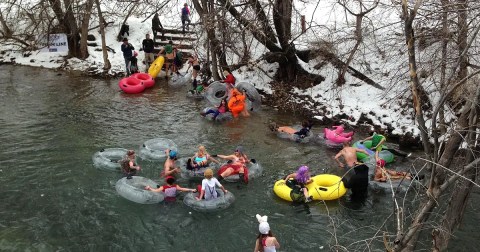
[273,174,347,201]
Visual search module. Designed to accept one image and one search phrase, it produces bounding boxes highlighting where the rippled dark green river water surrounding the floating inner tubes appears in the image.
[0,66,480,251]
